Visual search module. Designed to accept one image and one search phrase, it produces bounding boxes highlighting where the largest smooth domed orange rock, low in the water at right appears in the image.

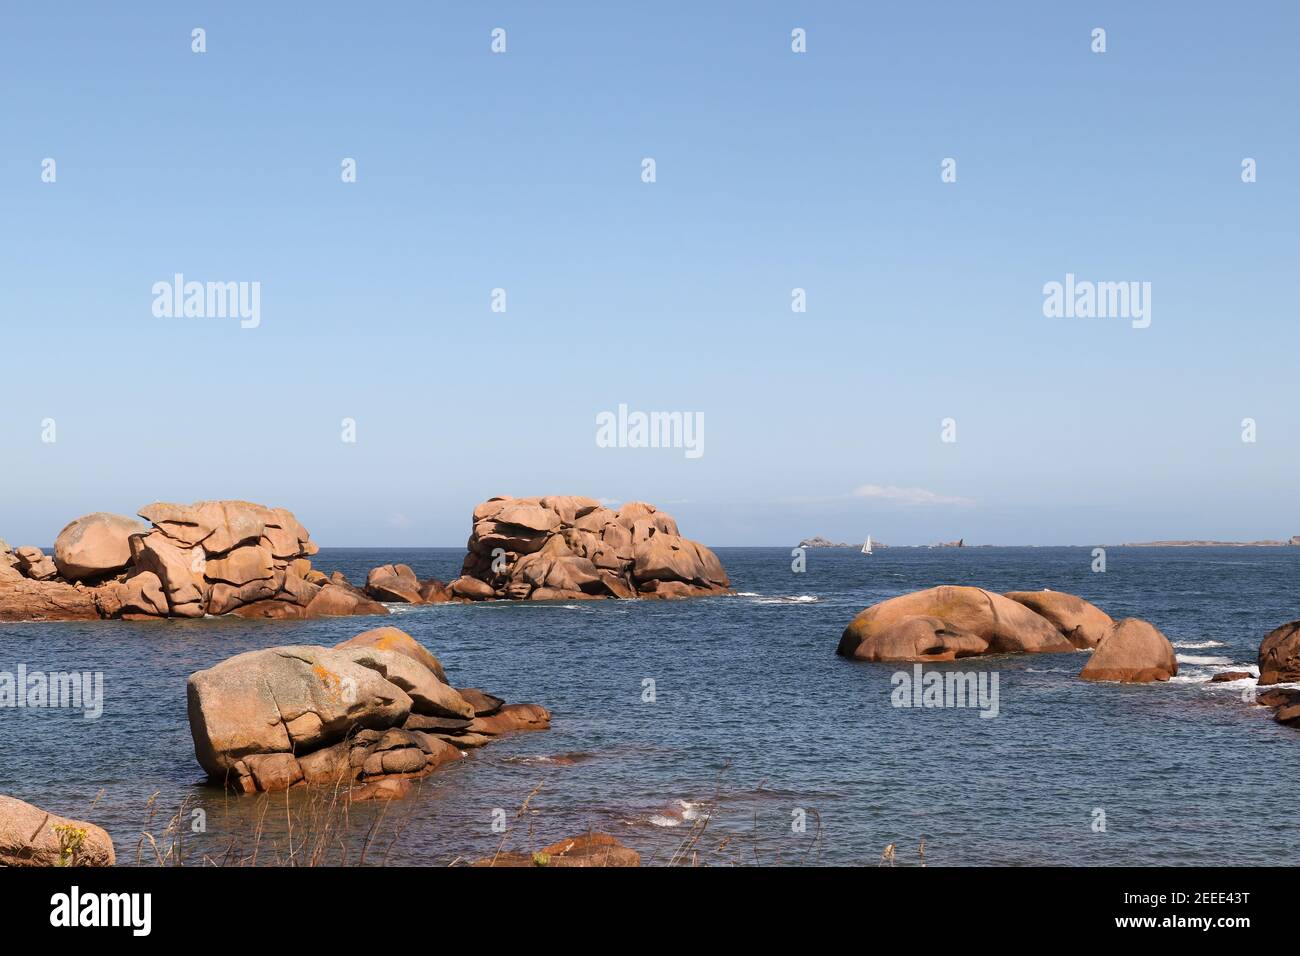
[836,585,1074,661]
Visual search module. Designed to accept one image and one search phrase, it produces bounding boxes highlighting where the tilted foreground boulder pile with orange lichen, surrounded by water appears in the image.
[187,627,550,793]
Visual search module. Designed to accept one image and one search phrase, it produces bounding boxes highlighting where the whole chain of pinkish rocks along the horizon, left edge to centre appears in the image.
[0,496,731,622]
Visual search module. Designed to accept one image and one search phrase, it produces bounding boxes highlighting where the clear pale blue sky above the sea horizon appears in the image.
[0,1,1300,546]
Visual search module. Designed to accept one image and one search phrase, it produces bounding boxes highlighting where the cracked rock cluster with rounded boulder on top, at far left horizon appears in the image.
[0,501,387,620]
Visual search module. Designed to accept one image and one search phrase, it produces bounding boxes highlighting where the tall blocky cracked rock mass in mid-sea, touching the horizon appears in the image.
[450,496,731,601]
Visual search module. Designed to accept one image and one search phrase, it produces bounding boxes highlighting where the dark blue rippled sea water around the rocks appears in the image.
[0,548,1300,866]
